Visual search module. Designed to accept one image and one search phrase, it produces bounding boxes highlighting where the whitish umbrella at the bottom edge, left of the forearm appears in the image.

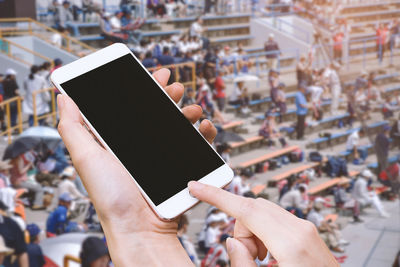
[39,233,101,267]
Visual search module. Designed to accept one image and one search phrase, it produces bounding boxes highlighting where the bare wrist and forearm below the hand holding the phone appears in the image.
[104,225,193,267]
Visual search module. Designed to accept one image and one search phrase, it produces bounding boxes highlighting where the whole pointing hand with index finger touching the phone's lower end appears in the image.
[188,182,339,267]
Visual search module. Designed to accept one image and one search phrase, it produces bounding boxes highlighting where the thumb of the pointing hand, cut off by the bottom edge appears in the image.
[226,238,257,267]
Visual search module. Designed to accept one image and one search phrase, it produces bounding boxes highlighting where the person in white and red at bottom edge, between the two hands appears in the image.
[201,234,230,267]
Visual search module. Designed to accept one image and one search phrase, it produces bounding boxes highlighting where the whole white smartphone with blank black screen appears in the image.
[51,44,233,220]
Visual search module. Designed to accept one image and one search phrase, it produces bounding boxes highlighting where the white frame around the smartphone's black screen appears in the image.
[50,43,233,221]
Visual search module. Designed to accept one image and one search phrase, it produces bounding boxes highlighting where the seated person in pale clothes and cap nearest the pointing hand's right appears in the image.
[307,198,349,253]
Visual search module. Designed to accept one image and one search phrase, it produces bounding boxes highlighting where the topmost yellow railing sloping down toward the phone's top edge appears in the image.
[0,18,96,57]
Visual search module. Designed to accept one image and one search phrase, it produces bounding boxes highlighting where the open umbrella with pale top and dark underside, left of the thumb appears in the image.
[3,126,61,160]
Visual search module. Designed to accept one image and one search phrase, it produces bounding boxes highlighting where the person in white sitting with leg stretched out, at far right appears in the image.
[352,169,390,218]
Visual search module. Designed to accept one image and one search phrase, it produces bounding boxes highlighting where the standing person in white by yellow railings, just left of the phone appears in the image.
[22,65,51,127]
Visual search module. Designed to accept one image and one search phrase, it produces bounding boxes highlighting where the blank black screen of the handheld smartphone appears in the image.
[61,54,224,205]
